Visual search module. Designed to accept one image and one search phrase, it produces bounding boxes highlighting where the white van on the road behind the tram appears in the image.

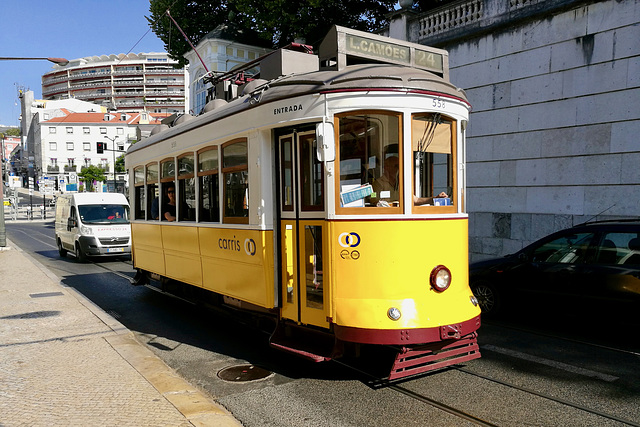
[56,193,131,261]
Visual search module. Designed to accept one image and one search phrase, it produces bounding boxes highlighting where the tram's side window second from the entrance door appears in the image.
[198,147,220,222]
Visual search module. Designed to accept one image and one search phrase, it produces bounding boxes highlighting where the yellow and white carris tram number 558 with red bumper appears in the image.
[126,27,480,379]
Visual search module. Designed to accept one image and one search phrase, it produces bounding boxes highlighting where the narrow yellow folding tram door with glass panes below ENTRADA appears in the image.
[278,131,329,327]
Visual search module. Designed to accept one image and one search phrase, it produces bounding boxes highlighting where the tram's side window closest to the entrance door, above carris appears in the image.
[222,139,249,223]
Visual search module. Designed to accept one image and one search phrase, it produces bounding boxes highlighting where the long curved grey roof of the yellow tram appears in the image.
[128,64,468,156]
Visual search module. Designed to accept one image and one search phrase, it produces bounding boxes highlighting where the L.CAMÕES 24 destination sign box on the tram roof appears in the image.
[319,26,449,79]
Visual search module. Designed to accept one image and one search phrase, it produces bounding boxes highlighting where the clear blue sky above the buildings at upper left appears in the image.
[0,0,164,126]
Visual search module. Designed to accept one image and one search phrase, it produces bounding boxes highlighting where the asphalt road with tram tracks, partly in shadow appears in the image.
[7,221,640,426]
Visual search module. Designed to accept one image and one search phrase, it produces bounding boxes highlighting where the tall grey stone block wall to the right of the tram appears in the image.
[400,0,640,260]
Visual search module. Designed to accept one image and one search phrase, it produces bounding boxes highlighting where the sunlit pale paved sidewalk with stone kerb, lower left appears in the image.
[0,241,241,427]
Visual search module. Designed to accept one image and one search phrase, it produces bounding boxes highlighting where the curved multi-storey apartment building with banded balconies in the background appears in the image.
[42,52,189,114]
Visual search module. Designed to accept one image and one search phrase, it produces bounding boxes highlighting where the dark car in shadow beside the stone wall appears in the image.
[470,221,640,316]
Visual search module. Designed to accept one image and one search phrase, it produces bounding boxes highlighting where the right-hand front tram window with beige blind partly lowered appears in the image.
[411,114,455,206]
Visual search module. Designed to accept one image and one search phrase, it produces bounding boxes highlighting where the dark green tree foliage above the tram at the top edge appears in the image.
[147,0,397,65]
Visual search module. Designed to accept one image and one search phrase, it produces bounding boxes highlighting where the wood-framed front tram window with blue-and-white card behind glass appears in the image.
[338,113,403,209]
